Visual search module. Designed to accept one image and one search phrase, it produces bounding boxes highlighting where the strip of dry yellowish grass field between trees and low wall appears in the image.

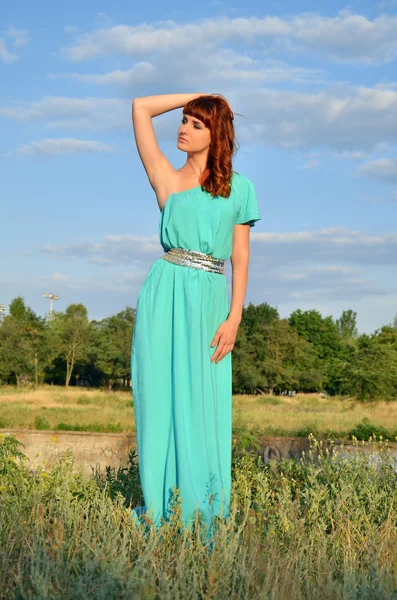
[0,386,397,439]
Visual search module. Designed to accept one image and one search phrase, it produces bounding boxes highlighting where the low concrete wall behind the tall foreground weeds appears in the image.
[0,429,397,474]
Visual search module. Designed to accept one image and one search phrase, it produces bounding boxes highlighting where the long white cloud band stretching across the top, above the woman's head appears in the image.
[62,10,397,64]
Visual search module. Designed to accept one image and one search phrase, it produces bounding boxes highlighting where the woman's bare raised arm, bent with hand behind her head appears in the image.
[132,94,203,191]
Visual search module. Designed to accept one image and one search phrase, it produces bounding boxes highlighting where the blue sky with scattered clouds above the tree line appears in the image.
[0,0,397,333]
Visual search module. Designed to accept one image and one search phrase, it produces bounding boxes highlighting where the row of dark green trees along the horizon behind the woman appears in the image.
[0,296,397,401]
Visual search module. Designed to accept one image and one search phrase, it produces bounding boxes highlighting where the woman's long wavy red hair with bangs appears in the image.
[183,94,237,198]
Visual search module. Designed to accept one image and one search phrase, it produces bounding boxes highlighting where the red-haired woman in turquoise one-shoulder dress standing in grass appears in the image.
[131,94,261,526]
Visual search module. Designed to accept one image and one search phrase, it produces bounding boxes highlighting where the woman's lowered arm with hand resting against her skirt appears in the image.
[210,223,251,364]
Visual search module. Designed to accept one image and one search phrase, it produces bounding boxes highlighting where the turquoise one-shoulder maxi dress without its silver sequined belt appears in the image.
[131,172,261,526]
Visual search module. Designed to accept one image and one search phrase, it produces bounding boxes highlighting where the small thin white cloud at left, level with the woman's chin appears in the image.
[10,138,113,156]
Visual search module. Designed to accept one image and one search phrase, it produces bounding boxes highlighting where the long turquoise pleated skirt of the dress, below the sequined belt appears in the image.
[131,259,232,525]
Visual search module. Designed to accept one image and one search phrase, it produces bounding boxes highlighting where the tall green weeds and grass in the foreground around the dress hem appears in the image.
[0,437,397,600]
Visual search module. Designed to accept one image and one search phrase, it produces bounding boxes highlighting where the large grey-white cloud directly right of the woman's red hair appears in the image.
[232,84,397,152]
